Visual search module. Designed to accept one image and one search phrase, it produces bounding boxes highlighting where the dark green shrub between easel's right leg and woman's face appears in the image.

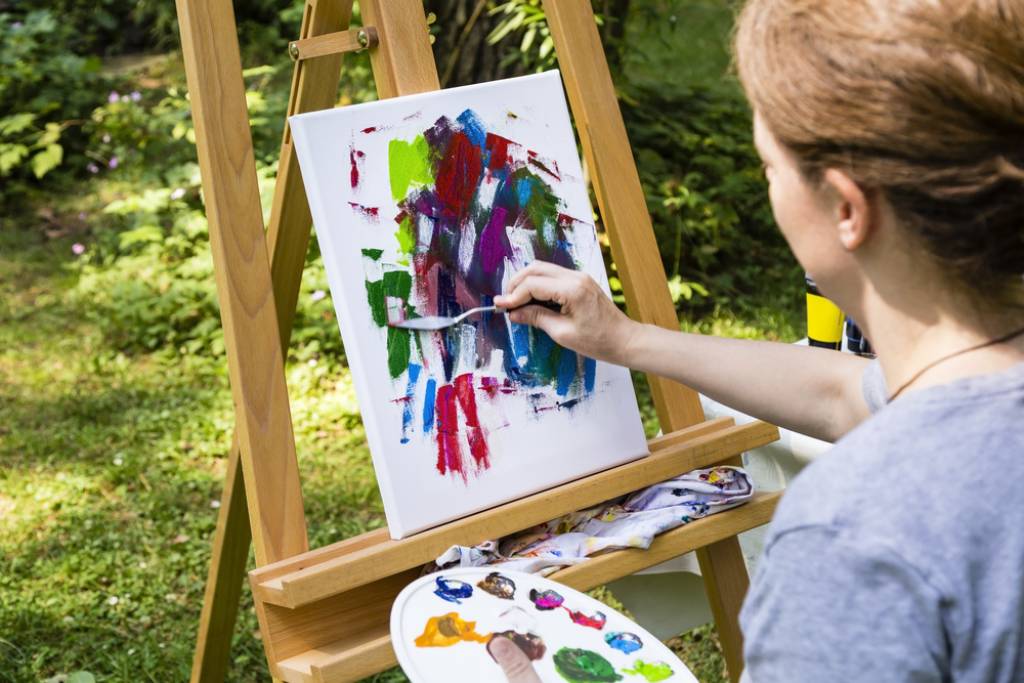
[621,87,803,310]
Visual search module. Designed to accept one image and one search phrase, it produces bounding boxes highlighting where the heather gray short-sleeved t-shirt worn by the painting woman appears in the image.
[740,364,1024,683]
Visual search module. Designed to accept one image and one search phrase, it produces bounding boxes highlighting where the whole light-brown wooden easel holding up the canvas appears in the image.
[176,0,778,682]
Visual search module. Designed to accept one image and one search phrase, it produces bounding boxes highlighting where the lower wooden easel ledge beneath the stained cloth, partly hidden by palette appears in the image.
[274,492,781,683]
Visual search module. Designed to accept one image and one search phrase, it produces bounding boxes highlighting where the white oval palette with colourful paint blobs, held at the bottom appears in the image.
[391,567,696,683]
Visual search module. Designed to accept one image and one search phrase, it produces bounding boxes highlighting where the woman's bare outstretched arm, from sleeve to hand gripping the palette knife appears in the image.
[495,262,868,441]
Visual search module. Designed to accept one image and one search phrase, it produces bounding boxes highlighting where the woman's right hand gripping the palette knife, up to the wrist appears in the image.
[495,261,641,366]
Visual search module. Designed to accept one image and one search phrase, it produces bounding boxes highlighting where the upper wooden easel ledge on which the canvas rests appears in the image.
[249,418,778,608]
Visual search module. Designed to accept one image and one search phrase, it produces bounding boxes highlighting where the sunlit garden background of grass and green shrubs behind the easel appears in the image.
[0,0,803,682]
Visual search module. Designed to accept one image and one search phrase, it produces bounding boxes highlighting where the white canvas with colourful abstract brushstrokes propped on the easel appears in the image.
[289,72,647,538]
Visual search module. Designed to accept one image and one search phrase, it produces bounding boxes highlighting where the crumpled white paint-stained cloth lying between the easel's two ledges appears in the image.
[430,466,754,574]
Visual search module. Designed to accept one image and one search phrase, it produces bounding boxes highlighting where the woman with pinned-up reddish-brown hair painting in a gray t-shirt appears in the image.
[494,0,1024,683]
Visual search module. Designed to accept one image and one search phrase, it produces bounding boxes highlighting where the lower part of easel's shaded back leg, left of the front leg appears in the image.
[190,438,252,683]
